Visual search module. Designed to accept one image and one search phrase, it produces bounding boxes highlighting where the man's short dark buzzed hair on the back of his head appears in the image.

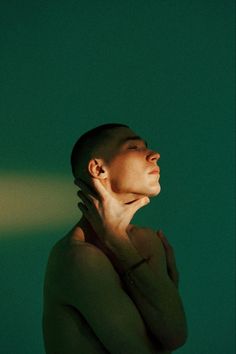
[71,123,129,177]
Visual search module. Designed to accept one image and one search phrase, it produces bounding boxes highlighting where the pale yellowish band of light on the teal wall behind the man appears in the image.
[0,172,81,237]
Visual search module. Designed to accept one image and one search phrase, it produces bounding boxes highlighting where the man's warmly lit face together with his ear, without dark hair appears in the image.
[75,128,161,203]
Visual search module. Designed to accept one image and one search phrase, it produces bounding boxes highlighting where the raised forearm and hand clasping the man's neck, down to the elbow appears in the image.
[78,179,187,350]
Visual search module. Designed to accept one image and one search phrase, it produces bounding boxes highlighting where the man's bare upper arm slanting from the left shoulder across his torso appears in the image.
[63,245,170,354]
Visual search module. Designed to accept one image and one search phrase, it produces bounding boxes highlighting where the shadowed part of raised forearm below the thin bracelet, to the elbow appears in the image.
[125,265,187,350]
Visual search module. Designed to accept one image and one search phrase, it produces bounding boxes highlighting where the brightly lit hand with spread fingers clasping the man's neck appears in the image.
[76,178,149,243]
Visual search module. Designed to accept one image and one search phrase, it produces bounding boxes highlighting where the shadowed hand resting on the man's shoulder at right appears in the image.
[157,230,179,288]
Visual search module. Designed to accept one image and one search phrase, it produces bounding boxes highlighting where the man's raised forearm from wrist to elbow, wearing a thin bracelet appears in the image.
[108,235,187,350]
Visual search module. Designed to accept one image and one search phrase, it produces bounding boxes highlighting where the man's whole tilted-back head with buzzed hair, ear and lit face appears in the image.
[71,123,160,201]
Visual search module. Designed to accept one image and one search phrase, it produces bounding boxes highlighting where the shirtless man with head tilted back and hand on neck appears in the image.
[43,123,187,354]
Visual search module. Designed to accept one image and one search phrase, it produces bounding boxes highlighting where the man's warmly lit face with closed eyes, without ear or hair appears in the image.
[103,128,161,197]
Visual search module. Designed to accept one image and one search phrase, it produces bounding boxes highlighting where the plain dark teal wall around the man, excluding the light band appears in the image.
[0,0,235,354]
